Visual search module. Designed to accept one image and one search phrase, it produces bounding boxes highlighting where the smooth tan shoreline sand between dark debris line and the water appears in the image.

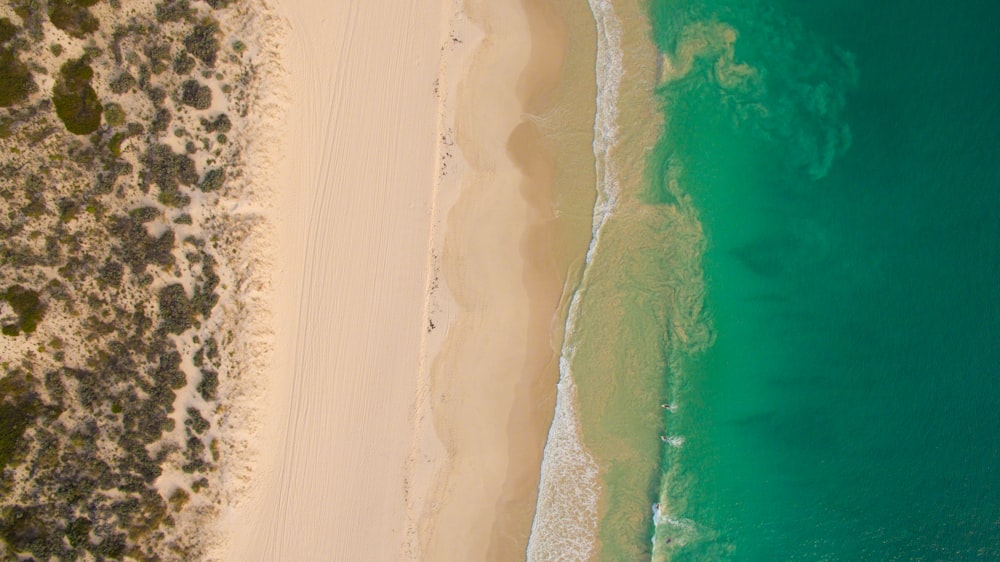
[404,0,593,560]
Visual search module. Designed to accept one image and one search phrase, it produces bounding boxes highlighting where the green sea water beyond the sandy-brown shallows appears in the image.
[640,0,1000,561]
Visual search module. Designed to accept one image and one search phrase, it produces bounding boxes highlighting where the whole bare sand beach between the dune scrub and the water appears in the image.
[220,0,580,561]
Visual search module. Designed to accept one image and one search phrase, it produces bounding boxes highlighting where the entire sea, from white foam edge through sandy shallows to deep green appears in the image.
[528,0,1000,561]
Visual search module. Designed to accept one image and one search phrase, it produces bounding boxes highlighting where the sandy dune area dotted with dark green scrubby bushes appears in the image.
[0,0,266,560]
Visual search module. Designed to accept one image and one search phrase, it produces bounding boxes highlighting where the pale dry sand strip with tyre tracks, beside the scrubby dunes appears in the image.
[227,0,442,560]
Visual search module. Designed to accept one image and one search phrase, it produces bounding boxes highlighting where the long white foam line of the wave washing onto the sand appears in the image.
[527,0,623,562]
